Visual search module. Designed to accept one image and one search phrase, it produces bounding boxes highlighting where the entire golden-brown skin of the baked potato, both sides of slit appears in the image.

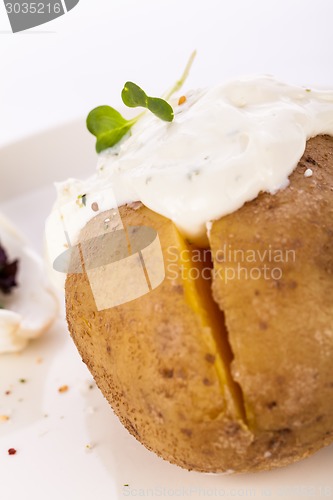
[66,137,333,472]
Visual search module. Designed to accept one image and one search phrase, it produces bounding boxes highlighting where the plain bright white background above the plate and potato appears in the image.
[0,0,333,145]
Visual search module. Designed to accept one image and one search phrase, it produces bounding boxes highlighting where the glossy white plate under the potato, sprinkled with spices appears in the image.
[0,121,333,500]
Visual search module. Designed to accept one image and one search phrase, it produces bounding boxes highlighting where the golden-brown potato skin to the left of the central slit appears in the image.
[66,205,253,472]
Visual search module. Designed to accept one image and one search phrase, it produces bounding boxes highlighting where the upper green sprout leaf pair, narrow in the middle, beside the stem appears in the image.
[121,82,174,122]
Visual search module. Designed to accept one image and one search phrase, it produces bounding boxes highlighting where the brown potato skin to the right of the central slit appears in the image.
[210,136,333,460]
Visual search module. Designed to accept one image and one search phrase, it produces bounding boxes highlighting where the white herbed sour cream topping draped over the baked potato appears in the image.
[46,76,333,258]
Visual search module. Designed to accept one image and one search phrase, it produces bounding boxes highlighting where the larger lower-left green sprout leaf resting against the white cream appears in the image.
[87,106,136,153]
